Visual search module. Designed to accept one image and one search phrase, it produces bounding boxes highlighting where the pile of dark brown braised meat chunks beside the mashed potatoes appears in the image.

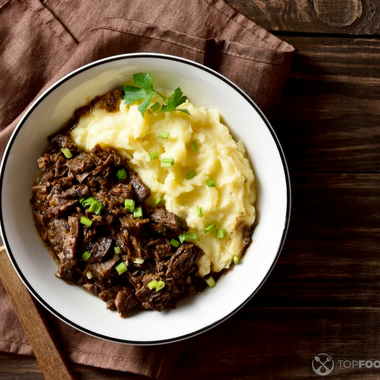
[31,134,203,317]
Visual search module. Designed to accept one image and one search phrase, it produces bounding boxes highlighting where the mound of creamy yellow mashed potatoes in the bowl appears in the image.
[71,97,256,276]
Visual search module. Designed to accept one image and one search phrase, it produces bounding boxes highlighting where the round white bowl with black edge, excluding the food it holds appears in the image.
[0,53,290,345]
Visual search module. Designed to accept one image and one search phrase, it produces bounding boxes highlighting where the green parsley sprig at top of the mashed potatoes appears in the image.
[122,73,190,117]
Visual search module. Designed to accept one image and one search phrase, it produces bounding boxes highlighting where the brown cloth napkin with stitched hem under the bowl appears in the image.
[0,0,294,379]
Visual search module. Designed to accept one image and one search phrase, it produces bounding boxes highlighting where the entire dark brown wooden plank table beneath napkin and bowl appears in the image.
[0,0,380,380]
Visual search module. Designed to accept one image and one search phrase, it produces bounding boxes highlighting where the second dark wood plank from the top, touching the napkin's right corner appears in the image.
[274,37,380,172]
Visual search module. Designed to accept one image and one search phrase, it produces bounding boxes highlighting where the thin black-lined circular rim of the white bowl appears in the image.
[0,53,291,346]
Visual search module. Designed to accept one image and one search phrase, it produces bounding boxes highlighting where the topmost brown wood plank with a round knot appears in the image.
[226,0,380,35]
